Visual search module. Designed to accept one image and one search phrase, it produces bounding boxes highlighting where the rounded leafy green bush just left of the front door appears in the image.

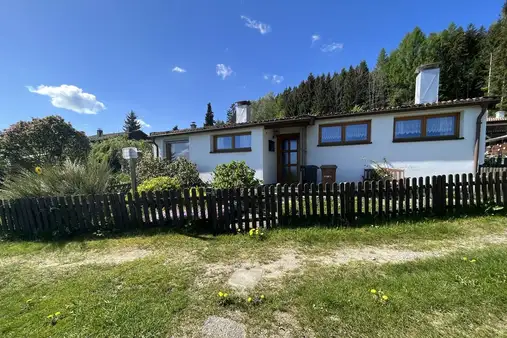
[211,161,262,189]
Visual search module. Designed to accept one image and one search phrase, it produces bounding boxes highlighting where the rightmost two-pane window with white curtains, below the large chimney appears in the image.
[394,113,460,142]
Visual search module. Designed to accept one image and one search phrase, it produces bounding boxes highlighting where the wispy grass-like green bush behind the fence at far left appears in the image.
[0,160,111,199]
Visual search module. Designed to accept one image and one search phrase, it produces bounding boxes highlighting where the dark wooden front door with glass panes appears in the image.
[277,134,299,183]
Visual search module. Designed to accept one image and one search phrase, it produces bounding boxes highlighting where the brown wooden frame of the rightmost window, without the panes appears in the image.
[393,112,461,143]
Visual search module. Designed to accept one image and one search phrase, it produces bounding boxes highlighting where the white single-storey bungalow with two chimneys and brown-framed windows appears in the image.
[150,66,499,184]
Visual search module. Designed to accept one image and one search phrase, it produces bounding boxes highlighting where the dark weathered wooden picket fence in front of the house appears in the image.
[0,172,507,238]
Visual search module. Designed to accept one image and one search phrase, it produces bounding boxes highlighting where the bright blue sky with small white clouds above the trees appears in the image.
[0,0,503,134]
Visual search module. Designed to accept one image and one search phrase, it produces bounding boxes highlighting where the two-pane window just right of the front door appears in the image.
[319,120,371,146]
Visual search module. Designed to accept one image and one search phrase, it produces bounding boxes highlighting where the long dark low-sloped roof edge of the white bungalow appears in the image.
[150,97,500,137]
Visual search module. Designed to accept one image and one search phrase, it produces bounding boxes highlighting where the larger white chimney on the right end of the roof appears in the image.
[415,63,440,104]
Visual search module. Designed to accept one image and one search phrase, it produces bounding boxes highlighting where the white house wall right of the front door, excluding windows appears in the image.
[306,106,486,182]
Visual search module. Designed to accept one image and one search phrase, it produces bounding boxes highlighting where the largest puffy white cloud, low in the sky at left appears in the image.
[27,85,106,114]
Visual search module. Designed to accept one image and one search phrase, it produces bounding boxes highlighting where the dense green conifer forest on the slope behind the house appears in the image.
[233,2,507,122]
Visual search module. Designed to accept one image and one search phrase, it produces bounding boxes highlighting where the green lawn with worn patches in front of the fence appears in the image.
[0,216,507,337]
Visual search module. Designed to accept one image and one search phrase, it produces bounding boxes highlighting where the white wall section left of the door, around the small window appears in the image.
[188,127,267,182]
